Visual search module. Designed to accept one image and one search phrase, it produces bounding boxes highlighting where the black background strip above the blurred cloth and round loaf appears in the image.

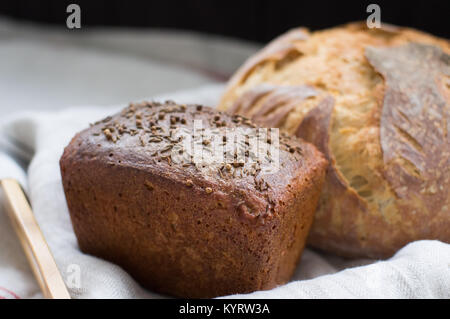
[0,0,450,42]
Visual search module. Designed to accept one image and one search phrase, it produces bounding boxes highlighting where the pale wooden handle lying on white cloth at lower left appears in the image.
[0,179,70,299]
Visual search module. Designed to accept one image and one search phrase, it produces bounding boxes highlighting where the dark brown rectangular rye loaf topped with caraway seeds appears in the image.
[60,101,327,298]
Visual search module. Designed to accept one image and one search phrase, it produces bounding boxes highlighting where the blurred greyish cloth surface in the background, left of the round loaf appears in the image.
[0,17,260,117]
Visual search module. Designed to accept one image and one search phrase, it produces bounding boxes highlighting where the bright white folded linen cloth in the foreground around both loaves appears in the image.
[0,85,450,298]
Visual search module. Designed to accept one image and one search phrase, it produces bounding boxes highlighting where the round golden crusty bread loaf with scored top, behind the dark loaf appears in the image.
[219,23,450,258]
